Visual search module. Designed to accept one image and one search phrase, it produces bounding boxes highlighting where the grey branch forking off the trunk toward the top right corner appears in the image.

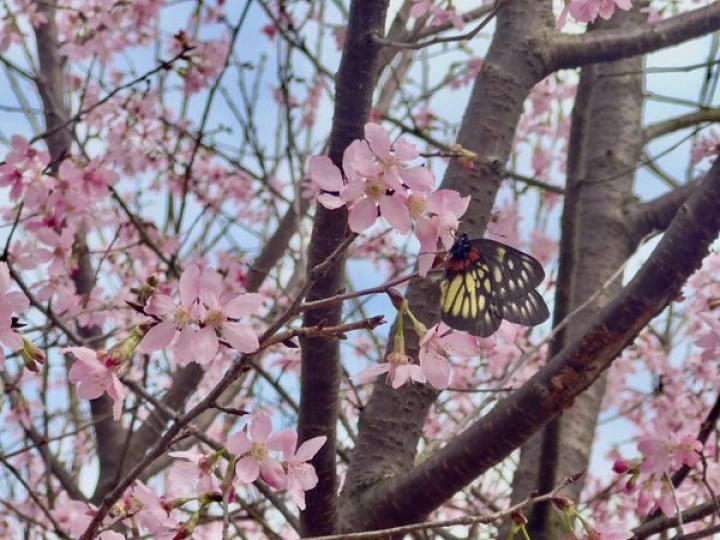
[550,2,720,71]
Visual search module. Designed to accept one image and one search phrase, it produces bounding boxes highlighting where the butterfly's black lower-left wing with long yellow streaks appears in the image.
[440,263,500,337]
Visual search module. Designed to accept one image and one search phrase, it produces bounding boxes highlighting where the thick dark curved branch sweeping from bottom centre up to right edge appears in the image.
[348,155,720,526]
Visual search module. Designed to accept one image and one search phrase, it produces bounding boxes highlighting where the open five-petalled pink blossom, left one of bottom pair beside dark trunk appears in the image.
[225,411,293,489]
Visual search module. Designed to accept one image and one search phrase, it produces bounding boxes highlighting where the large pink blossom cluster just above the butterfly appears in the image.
[309,122,470,275]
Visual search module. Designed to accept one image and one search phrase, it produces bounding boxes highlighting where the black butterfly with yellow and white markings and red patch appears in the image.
[440,233,550,337]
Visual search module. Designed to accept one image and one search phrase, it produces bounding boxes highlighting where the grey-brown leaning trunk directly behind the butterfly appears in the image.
[341,0,552,530]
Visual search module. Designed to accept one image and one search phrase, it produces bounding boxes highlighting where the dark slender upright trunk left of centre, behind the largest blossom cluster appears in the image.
[298,0,388,536]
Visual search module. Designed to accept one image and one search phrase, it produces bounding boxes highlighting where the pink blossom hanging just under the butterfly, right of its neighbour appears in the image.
[419,323,478,390]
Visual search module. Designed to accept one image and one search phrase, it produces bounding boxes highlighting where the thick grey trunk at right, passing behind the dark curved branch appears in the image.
[512,6,645,539]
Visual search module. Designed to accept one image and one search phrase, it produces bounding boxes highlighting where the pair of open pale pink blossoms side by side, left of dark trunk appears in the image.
[137,264,264,365]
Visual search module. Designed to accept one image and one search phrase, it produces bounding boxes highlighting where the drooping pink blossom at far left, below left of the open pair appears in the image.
[64,347,126,421]
